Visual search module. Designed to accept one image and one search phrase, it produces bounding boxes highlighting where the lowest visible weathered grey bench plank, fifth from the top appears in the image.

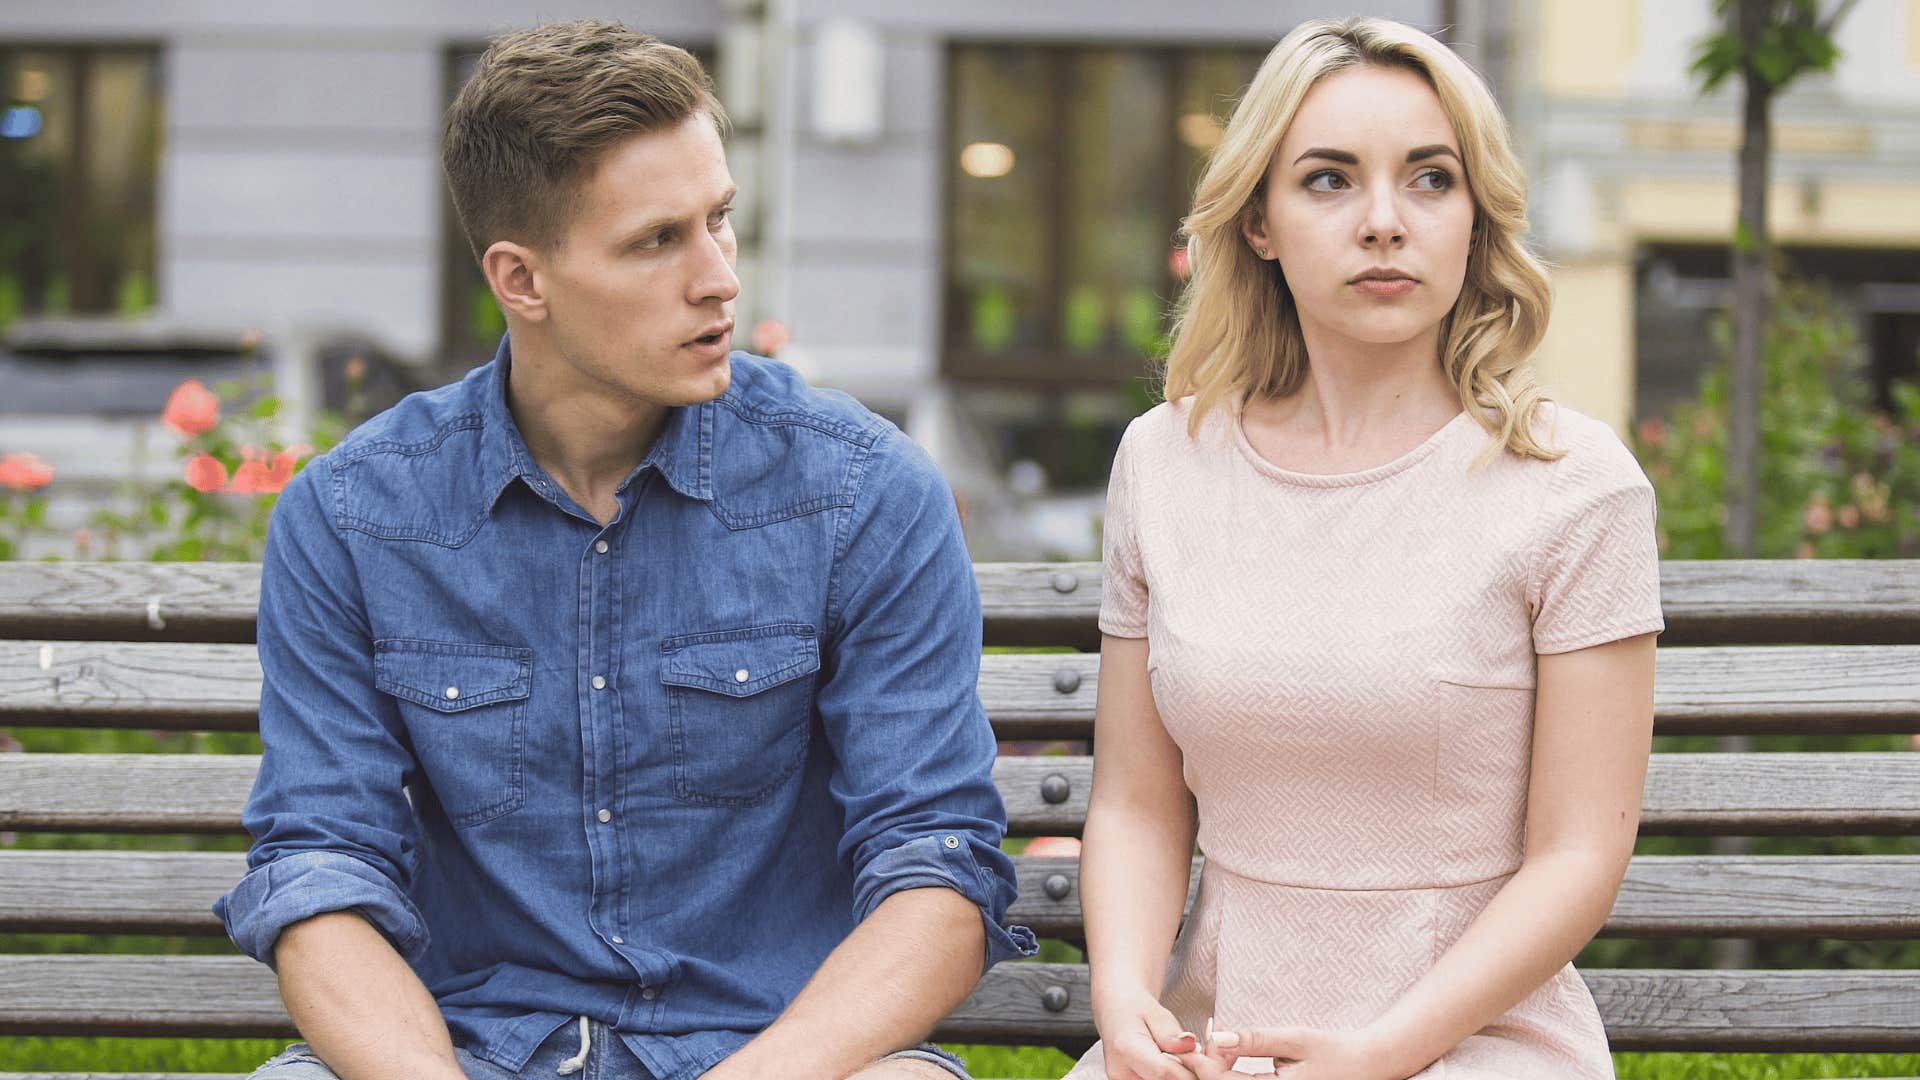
[0,955,1920,1051]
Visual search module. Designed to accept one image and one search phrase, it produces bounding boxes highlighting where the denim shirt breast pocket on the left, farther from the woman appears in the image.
[372,638,534,828]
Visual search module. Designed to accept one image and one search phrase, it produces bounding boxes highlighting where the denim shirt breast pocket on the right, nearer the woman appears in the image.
[660,623,820,807]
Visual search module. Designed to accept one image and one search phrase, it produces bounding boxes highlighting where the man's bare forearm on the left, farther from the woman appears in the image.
[273,911,465,1080]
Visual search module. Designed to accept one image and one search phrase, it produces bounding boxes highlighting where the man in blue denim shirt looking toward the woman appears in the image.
[217,23,1033,1080]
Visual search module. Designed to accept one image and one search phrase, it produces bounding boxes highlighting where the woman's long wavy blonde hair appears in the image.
[1165,17,1561,461]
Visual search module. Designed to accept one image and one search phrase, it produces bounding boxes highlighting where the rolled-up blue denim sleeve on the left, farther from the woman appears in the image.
[213,457,426,965]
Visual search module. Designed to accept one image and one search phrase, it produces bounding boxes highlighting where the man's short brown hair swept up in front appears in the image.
[440,19,728,259]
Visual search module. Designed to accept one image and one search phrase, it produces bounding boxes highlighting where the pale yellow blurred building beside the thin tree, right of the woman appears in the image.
[1505,0,1920,429]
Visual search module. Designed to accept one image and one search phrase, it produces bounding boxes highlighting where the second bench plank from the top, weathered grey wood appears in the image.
[0,642,1920,740]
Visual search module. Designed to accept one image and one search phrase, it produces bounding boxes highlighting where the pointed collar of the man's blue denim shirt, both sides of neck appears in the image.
[468,336,718,509]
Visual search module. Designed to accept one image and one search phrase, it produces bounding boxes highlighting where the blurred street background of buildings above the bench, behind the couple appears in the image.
[0,0,1920,559]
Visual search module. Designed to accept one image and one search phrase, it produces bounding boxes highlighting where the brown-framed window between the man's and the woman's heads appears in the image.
[943,44,1265,386]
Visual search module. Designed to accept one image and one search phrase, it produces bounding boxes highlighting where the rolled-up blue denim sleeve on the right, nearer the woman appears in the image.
[818,424,1037,967]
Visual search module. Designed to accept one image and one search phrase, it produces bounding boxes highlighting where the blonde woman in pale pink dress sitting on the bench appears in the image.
[1071,19,1663,1080]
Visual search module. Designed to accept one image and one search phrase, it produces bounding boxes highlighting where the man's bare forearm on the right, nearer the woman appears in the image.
[707,888,987,1080]
